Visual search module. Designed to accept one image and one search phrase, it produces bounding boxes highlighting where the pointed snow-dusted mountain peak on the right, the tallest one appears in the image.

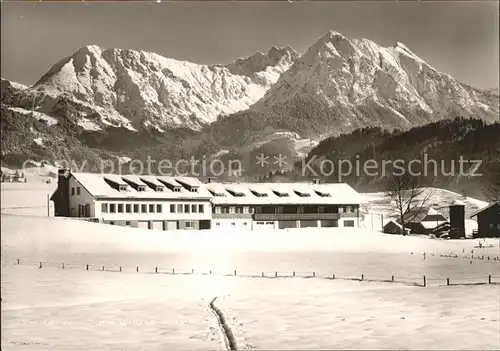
[245,31,498,134]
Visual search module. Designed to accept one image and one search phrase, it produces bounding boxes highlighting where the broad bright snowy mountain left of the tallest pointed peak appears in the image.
[29,46,298,130]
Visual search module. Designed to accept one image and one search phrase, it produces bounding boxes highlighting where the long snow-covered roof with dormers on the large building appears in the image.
[64,172,366,205]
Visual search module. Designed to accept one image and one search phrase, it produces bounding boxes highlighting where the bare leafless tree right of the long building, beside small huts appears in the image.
[386,172,432,235]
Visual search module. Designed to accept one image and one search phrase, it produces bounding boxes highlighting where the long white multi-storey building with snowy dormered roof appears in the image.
[51,169,363,230]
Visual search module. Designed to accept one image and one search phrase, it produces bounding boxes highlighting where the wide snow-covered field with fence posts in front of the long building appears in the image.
[1,181,500,350]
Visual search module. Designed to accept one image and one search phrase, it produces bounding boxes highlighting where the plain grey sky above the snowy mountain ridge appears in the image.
[1,0,499,89]
